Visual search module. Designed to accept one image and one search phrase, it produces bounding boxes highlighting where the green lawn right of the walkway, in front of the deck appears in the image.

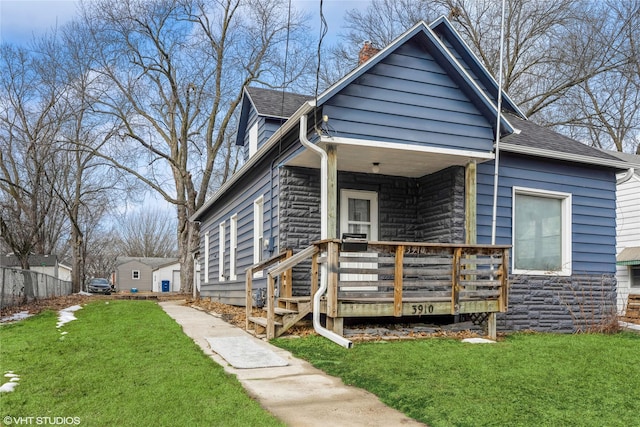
[273,333,640,427]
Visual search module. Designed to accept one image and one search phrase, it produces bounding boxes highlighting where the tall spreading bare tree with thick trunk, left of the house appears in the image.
[79,0,316,291]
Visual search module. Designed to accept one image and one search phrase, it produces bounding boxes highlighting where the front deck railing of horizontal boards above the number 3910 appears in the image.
[320,240,510,317]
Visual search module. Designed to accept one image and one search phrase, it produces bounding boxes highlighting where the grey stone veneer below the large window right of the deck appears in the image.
[497,274,617,333]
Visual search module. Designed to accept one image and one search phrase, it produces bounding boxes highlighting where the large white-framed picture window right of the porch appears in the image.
[513,187,571,275]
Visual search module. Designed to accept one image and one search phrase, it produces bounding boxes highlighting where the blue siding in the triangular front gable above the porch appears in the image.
[323,40,493,152]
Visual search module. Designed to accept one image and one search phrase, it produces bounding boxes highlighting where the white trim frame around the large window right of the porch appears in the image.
[511,187,573,276]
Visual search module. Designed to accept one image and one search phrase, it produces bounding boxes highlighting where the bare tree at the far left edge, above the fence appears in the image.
[0,45,66,269]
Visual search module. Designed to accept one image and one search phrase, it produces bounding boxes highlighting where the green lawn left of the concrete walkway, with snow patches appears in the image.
[0,301,282,426]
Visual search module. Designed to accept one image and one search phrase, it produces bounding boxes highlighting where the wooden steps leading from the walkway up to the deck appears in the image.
[247,297,311,338]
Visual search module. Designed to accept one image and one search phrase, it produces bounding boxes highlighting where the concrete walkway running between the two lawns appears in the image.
[159,301,424,427]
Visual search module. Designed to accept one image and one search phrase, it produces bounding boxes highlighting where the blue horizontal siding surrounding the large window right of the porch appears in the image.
[477,154,616,274]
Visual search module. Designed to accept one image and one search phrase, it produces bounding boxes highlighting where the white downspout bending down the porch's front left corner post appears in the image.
[300,114,353,348]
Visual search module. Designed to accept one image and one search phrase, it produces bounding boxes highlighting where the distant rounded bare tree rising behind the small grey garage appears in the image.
[116,208,178,258]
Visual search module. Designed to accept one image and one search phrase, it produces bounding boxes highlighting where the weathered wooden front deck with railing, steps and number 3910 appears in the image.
[246,240,510,339]
